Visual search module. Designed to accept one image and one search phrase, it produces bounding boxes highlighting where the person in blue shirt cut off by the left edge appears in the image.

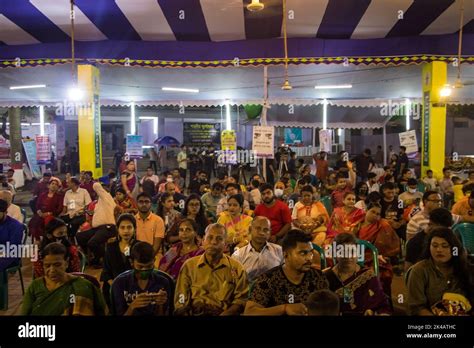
[0,199,25,272]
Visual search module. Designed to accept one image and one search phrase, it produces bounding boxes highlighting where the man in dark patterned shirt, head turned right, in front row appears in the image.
[244,230,329,316]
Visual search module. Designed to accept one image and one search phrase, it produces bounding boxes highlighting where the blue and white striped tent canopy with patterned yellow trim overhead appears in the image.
[0,0,474,67]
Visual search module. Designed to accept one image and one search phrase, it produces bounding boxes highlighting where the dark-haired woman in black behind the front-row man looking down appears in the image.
[100,214,137,304]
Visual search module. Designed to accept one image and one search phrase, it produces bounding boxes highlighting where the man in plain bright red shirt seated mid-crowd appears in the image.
[255,184,291,243]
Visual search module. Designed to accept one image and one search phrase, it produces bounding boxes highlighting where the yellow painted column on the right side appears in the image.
[421,62,448,178]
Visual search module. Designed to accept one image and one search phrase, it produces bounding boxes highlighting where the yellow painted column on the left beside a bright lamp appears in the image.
[77,65,102,178]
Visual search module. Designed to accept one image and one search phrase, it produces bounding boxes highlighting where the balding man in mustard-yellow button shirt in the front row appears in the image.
[174,224,248,315]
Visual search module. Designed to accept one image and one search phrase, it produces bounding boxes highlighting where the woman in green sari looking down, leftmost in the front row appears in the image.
[21,243,105,316]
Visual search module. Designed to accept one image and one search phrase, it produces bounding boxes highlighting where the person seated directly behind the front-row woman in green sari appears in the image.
[33,218,81,278]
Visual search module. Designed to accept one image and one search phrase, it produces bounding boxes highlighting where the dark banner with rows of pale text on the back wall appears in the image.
[183,122,221,147]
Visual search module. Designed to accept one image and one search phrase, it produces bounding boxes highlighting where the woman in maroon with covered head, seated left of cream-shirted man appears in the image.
[28,178,64,241]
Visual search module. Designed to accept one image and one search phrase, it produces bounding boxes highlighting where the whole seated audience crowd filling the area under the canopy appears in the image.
[0,146,474,315]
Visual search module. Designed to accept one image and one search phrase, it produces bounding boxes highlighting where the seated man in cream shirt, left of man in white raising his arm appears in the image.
[61,178,91,237]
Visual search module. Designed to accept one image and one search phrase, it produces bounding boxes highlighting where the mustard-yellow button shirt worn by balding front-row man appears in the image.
[174,254,248,311]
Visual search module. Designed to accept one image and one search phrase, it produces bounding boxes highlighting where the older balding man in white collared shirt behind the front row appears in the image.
[232,216,283,282]
